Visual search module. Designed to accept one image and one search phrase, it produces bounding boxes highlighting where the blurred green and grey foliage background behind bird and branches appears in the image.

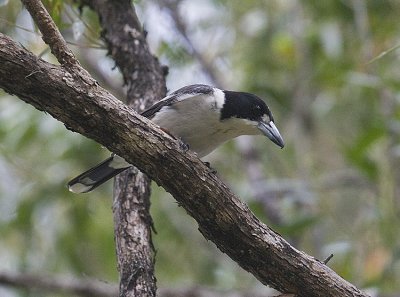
[0,0,400,296]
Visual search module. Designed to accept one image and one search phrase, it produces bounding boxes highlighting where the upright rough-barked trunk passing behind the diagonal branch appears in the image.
[75,0,166,296]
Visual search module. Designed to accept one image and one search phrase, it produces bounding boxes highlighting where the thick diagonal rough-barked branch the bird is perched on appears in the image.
[0,34,367,297]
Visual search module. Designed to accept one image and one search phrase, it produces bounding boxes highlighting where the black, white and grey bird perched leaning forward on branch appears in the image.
[68,84,285,193]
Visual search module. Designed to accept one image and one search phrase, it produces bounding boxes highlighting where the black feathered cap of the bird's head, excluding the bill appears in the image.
[221,91,274,121]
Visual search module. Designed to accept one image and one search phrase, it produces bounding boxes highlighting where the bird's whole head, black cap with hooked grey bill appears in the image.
[220,91,285,148]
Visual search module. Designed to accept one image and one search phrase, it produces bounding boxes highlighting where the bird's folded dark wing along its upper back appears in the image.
[141,84,214,119]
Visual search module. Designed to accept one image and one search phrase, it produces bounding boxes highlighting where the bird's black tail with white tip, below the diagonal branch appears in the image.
[68,155,132,193]
